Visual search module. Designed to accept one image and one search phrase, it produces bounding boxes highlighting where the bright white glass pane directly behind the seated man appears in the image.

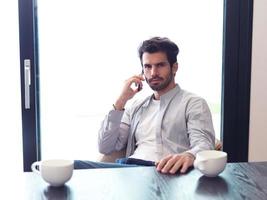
[38,0,223,160]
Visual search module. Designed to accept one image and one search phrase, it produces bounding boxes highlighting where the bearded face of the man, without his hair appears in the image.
[142,52,177,91]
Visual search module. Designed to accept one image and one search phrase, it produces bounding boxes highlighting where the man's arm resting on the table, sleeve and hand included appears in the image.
[157,98,215,174]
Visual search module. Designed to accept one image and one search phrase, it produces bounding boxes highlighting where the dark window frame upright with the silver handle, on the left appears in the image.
[18,0,41,171]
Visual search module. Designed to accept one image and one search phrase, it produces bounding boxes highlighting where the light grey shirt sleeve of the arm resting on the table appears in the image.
[186,98,215,156]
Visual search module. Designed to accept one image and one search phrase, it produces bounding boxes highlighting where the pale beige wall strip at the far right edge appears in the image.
[249,0,267,161]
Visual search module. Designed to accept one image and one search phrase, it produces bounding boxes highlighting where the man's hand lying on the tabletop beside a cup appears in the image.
[156,152,195,174]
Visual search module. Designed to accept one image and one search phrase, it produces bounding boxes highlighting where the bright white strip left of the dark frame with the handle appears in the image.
[0,0,23,172]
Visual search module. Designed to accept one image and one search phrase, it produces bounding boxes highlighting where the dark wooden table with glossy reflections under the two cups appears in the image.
[5,162,267,200]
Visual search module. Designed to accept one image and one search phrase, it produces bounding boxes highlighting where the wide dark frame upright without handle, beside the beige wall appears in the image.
[221,0,253,162]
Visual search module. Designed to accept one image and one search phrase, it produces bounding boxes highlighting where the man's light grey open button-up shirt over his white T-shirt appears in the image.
[98,84,215,160]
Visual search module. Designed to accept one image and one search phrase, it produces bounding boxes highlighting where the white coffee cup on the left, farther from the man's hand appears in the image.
[31,159,74,187]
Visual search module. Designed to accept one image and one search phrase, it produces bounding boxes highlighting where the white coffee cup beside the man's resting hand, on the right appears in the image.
[194,150,227,177]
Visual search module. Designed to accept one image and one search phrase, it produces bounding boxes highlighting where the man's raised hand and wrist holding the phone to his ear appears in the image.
[114,75,145,110]
